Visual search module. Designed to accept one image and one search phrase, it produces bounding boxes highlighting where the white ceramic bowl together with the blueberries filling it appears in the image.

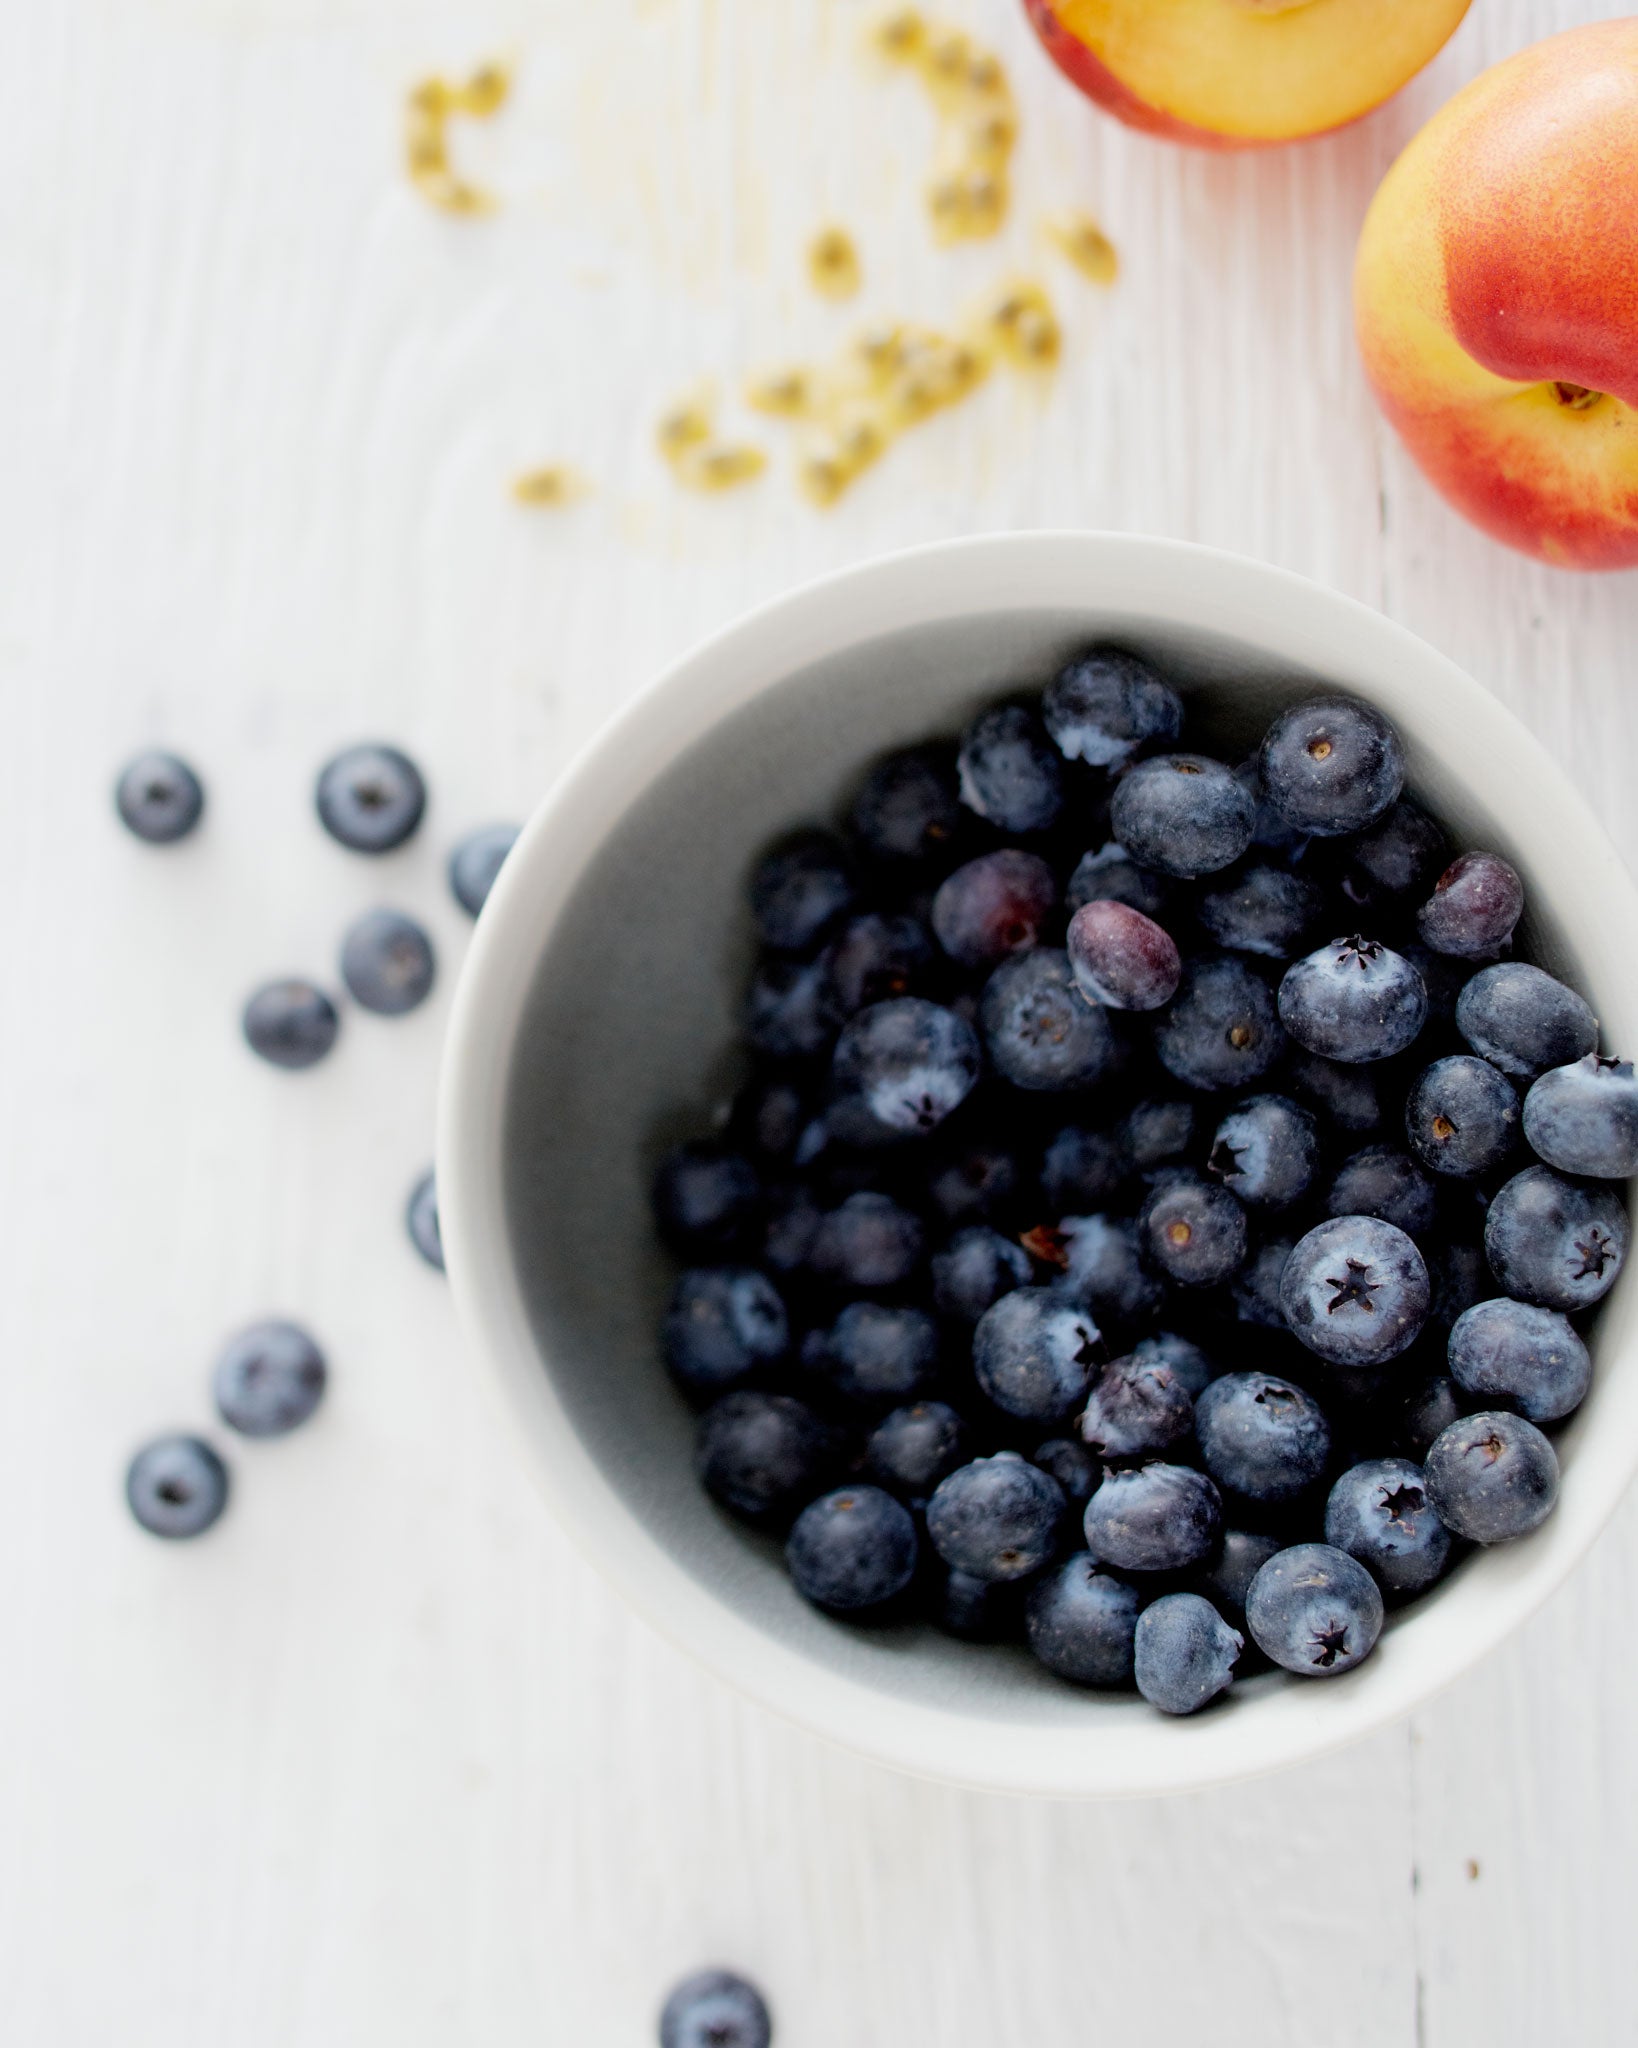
[438,535,1638,1794]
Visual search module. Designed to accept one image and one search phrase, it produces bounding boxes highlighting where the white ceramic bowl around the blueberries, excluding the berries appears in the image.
[438,532,1638,1794]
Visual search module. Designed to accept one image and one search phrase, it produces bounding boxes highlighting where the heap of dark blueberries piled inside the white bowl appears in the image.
[655,647,1638,1714]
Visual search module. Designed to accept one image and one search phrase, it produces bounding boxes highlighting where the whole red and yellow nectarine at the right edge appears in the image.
[1353,18,1638,569]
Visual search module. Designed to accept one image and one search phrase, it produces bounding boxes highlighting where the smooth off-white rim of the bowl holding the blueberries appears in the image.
[436,530,1638,1798]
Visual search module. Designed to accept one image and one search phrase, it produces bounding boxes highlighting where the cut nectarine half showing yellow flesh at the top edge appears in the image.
[1024,0,1470,150]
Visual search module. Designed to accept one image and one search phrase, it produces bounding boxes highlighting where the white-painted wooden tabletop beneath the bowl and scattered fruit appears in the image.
[0,0,1638,2048]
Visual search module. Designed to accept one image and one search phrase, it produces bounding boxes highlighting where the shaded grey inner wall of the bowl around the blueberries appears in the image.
[504,585,1621,1769]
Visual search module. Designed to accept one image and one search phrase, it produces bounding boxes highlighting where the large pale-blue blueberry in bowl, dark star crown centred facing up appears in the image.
[1280,1217,1429,1366]
